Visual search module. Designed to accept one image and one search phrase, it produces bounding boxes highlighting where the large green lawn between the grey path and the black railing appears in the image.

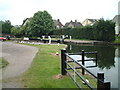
[23,45,96,88]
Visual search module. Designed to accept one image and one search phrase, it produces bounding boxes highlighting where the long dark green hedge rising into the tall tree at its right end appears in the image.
[54,19,115,41]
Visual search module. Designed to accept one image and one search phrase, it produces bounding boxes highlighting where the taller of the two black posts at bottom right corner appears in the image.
[97,72,104,90]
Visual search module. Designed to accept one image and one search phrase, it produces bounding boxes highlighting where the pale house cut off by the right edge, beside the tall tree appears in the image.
[113,15,120,35]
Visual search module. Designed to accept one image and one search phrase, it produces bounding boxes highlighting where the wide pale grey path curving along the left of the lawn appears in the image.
[0,42,38,88]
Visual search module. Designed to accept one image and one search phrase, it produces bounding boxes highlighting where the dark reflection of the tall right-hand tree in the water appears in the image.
[96,46,115,69]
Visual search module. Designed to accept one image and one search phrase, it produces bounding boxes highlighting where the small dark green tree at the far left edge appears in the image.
[2,20,13,34]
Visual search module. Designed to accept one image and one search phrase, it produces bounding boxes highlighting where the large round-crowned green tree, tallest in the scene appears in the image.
[29,11,54,37]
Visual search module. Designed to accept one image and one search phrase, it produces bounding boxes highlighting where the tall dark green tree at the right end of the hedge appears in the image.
[94,19,115,41]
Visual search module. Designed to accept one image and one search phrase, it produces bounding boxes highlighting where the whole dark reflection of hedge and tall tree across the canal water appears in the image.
[67,44,116,69]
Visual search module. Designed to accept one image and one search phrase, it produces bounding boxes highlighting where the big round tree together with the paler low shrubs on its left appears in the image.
[11,11,55,37]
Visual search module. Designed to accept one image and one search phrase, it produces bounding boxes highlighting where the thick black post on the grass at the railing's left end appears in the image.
[61,49,67,75]
